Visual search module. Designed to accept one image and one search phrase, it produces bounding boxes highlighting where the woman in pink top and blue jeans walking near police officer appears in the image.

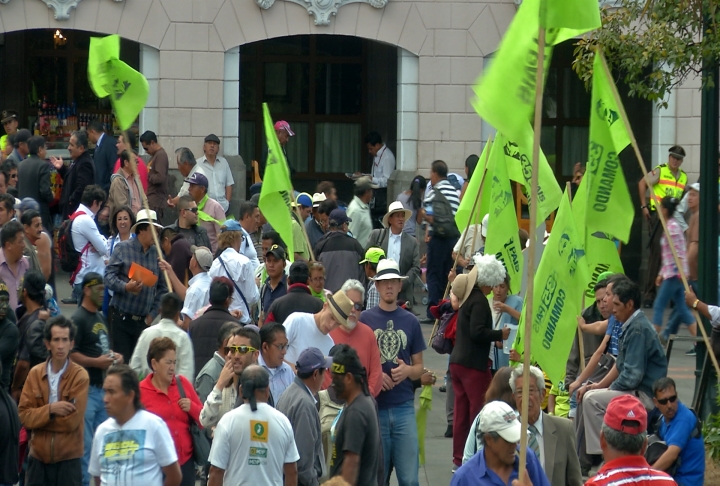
[653,196,697,336]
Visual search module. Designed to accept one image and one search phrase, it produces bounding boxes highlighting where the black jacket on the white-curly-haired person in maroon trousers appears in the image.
[450,287,502,371]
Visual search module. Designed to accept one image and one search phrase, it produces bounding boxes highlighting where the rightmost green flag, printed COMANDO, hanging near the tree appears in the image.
[584,54,635,243]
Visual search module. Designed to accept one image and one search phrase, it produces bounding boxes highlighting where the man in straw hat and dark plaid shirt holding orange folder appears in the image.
[105,209,168,364]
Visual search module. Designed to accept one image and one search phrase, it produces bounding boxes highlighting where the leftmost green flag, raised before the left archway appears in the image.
[88,35,150,130]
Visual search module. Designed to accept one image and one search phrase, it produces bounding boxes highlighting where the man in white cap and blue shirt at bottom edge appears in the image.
[450,401,550,486]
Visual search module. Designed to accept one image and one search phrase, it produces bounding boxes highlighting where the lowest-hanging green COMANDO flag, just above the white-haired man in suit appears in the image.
[513,193,590,383]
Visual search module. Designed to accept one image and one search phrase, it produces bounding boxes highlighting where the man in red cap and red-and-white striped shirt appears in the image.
[585,395,677,486]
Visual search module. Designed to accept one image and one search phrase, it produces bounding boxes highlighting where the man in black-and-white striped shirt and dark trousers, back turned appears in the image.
[422,160,460,322]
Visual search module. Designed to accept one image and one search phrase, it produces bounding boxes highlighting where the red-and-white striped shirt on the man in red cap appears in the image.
[585,456,677,486]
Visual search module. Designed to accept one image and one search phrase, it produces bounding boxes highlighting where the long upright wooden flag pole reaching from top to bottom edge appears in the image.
[518,23,545,478]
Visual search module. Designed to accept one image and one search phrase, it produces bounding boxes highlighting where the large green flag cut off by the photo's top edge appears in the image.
[472,0,601,138]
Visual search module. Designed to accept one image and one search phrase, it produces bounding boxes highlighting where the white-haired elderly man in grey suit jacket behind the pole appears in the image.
[510,365,583,486]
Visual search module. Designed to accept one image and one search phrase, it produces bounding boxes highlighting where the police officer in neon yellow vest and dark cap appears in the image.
[638,145,687,307]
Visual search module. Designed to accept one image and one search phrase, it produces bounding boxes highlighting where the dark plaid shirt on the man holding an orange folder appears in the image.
[105,238,168,317]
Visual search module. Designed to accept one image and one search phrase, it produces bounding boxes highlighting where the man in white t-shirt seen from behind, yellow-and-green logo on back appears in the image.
[208,365,300,486]
